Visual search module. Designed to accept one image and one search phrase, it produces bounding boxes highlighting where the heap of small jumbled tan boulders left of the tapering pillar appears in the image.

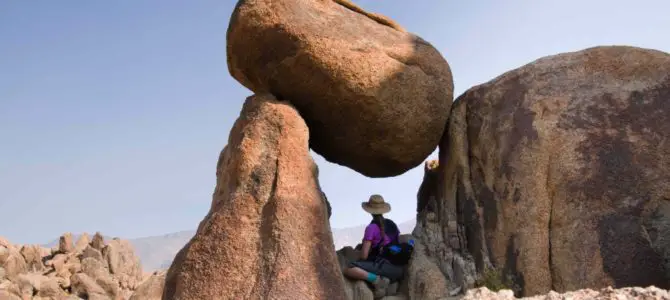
[0,233,153,300]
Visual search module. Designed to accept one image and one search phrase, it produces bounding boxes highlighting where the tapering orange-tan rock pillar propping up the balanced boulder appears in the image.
[163,95,346,300]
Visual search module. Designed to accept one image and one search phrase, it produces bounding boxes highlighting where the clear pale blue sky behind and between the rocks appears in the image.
[0,0,670,243]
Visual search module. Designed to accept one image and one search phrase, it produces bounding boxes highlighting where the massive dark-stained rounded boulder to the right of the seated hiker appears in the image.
[440,46,670,296]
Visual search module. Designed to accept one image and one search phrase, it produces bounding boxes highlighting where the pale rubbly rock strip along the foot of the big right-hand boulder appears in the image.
[462,286,670,300]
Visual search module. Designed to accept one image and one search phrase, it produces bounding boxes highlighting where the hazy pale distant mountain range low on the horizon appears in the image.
[44,220,416,272]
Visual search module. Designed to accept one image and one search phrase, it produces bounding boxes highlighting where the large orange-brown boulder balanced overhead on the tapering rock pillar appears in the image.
[227,0,453,177]
